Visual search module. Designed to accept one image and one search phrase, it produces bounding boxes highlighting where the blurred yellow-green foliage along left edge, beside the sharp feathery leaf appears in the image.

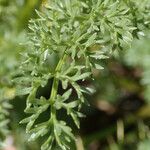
[0,0,37,145]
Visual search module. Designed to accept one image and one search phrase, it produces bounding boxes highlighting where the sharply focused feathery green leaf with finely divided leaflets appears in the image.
[13,0,149,150]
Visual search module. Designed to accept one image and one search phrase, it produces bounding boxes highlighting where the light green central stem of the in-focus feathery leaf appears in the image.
[49,52,67,121]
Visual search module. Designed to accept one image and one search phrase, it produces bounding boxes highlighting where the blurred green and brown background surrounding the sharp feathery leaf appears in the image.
[0,0,150,150]
